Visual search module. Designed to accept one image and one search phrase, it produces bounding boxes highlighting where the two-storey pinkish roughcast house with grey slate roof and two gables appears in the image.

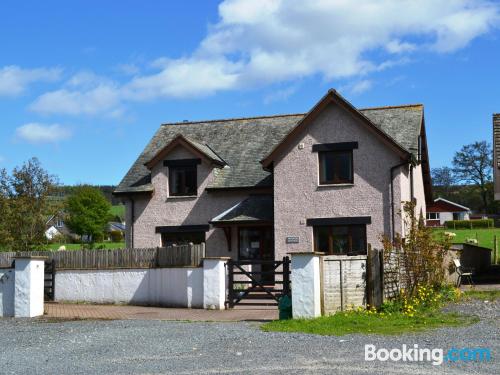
[114,90,432,259]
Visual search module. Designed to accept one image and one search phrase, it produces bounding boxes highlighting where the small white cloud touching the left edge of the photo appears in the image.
[0,65,61,96]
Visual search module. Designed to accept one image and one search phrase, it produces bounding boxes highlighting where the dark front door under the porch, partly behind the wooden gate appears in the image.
[239,226,274,285]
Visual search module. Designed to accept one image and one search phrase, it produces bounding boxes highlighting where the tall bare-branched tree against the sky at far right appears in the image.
[453,141,493,212]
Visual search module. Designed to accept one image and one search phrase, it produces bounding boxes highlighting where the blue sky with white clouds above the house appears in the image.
[0,0,500,185]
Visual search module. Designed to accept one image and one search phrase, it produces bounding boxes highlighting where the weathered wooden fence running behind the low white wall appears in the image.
[0,244,205,270]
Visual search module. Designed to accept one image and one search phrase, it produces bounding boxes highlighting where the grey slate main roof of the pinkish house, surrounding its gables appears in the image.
[115,104,423,194]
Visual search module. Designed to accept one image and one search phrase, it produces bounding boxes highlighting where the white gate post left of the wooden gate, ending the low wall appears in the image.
[203,257,231,310]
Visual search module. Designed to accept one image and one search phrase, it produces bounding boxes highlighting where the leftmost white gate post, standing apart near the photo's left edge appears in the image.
[14,256,47,318]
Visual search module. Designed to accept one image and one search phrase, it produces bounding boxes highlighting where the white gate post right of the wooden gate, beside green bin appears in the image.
[290,252,322,318]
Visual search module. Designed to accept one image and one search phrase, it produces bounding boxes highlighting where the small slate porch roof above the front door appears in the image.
[210,195,273,224]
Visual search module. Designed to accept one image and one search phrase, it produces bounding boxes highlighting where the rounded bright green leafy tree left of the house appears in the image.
[65,185,111,243]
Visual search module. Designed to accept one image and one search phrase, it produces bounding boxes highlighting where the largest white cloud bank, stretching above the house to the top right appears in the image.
[31,0,500,115]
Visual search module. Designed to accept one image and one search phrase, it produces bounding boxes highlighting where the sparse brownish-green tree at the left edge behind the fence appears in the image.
[0,158,56,251]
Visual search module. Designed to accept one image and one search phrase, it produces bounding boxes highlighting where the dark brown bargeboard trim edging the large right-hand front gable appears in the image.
[260,89,409,168]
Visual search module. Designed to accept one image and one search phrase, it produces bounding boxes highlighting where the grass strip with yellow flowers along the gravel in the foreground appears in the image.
[262,312,478,336]
